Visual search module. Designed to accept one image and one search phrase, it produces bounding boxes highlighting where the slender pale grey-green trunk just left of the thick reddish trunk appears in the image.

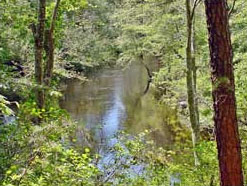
[186,0,200,165]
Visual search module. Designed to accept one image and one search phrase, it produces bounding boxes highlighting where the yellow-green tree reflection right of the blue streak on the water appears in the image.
[123,61,179,146]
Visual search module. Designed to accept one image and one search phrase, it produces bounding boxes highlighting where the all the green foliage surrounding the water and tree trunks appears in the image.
[0,0,247,186]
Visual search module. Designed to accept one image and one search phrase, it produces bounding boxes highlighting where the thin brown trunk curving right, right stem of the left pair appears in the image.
[44,0,60,86]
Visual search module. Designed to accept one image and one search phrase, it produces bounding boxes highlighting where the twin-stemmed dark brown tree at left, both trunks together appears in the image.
[32,0,86,109]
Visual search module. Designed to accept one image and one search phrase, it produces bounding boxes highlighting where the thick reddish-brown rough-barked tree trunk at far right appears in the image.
[205,0,243,186]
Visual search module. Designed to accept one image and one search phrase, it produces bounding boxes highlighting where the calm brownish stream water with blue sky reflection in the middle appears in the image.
[61,63,177,152]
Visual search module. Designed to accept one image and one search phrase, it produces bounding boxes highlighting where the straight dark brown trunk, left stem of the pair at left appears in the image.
[32,0,46,109]
